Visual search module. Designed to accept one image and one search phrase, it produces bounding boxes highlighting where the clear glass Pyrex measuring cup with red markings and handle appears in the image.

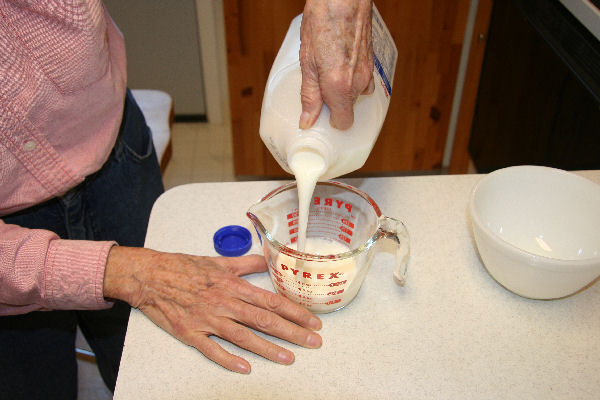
[246,181,409,313]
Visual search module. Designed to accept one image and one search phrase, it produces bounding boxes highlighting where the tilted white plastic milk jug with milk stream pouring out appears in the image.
[260,7,398,254]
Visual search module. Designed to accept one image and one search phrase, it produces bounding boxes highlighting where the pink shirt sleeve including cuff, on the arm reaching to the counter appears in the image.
[0,220,116,315]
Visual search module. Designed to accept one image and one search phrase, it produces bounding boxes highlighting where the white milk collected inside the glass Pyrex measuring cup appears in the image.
[275,237,360,313]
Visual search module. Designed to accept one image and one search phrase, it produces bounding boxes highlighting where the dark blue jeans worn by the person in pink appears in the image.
[0,90,164,399]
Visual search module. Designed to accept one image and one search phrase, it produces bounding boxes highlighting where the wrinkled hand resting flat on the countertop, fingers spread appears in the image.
[104,246,321,373]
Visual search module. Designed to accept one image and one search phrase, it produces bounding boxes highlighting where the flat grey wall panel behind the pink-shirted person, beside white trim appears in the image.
[104,0,206,115]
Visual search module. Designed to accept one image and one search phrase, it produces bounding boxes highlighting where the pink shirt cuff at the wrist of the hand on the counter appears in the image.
[44,239,117,310]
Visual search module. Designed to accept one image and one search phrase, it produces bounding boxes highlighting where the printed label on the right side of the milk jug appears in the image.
[371,6,398,97]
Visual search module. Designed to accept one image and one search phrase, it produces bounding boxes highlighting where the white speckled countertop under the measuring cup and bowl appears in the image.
[114,171,600,400]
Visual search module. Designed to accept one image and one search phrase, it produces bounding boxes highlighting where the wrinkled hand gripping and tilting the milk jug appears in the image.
[300,0,375,129]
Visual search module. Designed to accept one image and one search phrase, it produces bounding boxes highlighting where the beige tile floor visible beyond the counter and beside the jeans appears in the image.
[76,123,235,400]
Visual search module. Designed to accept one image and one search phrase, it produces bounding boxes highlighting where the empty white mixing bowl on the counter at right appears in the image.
[469,166,600,299]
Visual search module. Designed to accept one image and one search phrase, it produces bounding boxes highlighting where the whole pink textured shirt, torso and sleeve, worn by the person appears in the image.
[0,0,126,314]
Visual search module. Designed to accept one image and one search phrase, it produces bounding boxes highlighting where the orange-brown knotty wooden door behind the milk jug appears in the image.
[224,0,478,177]
